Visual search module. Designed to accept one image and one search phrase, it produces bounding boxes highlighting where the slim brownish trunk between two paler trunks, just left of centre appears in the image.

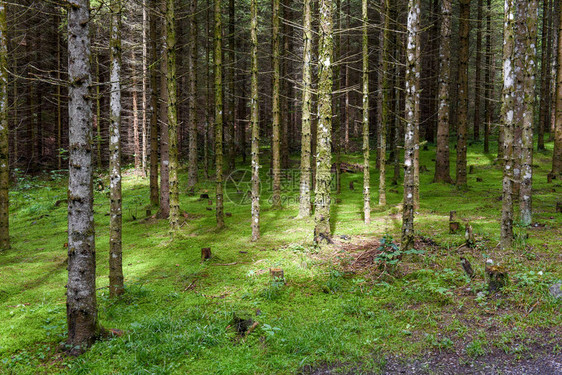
[271,0,281,208]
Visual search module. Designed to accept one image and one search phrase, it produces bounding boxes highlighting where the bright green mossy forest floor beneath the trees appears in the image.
[0,143,562,374]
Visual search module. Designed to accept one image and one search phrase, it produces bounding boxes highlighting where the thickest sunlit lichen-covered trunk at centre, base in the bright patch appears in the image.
[314,0,332,243]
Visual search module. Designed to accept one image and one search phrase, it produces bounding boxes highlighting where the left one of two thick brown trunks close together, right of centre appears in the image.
[433,0,453,183]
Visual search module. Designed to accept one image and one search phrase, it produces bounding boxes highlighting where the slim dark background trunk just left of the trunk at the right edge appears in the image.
[537,0,552,151]
